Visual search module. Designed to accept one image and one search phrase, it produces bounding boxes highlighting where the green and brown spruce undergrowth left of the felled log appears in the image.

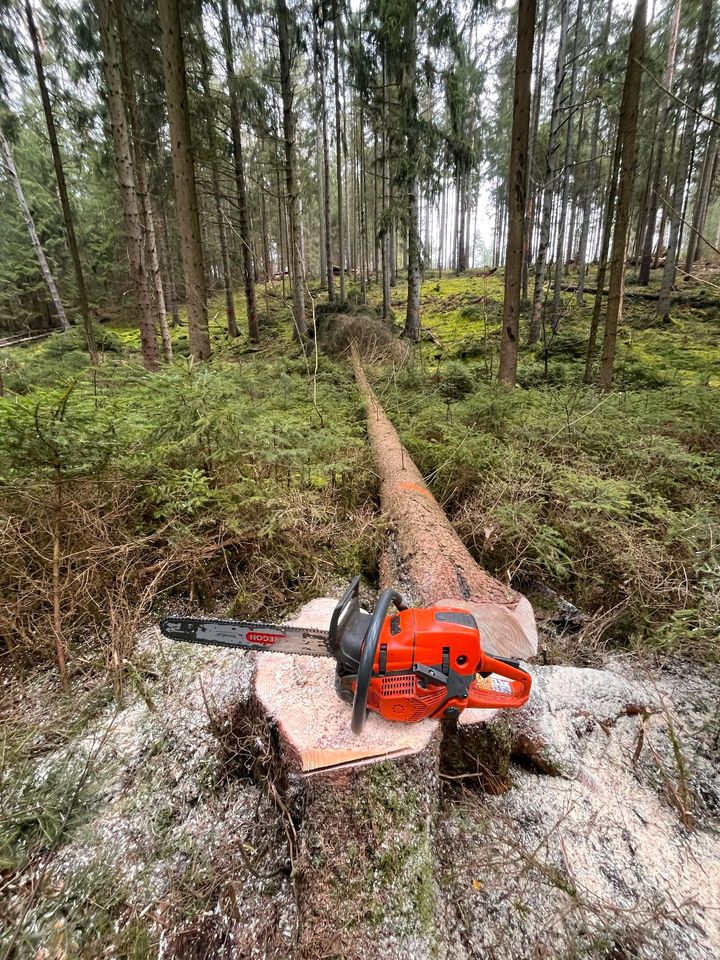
[0,330,380,683]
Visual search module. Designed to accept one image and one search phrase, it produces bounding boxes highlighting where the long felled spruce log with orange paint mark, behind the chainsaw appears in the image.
[353,354,538,658]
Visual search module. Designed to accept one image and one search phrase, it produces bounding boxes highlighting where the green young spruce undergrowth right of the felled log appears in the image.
[374,362,720,656]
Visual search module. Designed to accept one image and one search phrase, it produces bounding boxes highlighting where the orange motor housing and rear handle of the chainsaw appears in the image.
[352,605,532,723]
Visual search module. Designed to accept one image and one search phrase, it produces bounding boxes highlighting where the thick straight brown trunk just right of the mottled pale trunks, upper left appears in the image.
[158,0,210,360]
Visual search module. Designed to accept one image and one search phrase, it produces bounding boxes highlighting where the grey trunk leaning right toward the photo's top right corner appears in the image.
[657,0,713,322]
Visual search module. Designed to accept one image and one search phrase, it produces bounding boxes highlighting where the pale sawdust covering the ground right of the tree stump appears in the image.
[439,660,720,960]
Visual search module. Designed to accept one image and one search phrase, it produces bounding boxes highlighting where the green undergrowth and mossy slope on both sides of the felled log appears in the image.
[0,274,720,676]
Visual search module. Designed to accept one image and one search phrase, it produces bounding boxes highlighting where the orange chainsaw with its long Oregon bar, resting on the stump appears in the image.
[160,577,532,734]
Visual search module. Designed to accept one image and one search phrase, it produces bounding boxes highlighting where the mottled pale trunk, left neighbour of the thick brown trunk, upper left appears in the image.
[96,0,158,370]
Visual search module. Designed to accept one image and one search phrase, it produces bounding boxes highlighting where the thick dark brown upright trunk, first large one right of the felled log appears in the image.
[498,0,535,387]
